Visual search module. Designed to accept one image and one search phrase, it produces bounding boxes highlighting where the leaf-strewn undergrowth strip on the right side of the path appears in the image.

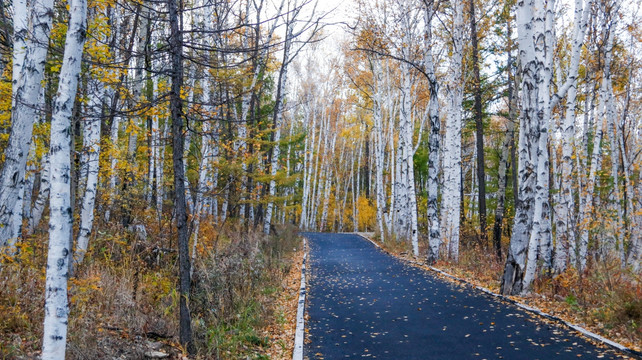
[359,233,642,352]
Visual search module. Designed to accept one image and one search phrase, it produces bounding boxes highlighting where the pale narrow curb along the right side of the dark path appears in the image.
[351,233,642,359]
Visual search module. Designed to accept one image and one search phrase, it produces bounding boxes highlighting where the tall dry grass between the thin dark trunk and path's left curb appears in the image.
[193,224,301,359]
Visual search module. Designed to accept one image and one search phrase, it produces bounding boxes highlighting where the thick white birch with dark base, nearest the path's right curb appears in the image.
[502,0,590,294]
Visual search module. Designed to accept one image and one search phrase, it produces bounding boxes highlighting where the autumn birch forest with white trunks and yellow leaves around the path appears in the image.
[0,0,642,359]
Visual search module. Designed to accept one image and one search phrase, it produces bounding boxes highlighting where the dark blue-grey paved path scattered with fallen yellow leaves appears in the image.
[304,233,619,360]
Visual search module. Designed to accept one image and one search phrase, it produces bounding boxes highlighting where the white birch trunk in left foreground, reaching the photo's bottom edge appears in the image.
[42,0,87,354]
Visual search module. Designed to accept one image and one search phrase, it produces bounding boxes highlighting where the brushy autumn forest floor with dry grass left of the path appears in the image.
[0,223,302,360]
